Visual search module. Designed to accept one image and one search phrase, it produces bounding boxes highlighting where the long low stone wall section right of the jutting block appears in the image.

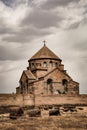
[35,95,87,106]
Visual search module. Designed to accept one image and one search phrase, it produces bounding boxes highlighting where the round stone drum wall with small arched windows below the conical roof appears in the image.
[29,59,60,78]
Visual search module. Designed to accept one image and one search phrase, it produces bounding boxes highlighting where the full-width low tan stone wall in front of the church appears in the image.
[0,94,87,107]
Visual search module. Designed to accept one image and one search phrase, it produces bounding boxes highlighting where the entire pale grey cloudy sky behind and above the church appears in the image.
[0,0,87,93]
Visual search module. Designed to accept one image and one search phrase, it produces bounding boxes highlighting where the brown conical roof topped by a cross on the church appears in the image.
[30,44,61,60]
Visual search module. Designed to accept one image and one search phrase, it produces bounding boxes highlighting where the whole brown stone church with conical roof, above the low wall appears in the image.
[16,44,79,95]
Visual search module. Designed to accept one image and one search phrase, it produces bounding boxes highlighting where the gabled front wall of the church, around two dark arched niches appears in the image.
[34,69,79,95]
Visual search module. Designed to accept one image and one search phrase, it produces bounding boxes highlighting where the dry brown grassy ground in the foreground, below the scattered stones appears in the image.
[0,114,87,130]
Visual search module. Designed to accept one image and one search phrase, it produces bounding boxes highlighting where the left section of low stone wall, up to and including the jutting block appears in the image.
[0,94,34,106]
